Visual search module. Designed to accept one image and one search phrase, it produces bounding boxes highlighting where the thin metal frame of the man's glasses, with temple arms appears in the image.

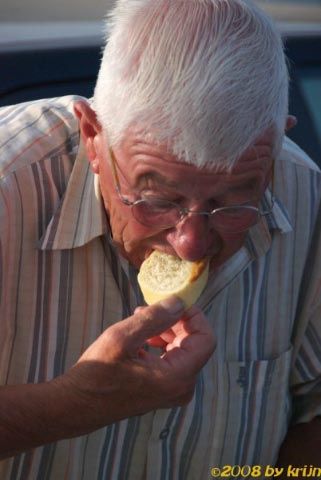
[109,147,275,232]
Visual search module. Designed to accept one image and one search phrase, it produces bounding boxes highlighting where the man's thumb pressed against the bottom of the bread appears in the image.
[113,295,186,355]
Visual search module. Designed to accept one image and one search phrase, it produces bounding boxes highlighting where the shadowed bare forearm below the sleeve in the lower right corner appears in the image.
[277,417,321,468]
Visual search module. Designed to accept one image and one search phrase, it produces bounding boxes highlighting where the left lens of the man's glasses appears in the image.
[132,199,181,227]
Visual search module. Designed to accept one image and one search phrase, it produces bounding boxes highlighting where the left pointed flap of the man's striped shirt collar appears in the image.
[38,142,108,250]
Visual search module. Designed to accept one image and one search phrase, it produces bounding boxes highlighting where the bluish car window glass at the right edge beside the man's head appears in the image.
[298,66,321,143]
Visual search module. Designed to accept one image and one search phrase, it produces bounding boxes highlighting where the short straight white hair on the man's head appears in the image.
[93,0,288,169]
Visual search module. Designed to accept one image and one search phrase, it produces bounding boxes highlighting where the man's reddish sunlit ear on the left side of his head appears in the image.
[74,100,102,173]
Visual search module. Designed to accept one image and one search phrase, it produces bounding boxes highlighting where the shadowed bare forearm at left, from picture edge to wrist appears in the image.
[0,382,91,458]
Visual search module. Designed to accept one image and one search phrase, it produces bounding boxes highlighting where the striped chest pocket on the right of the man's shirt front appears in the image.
[212,348,292,465]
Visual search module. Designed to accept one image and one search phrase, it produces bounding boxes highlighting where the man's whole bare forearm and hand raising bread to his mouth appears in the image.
[0,297,215,458]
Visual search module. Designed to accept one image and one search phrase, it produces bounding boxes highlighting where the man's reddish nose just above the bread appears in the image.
[167,214,216,262]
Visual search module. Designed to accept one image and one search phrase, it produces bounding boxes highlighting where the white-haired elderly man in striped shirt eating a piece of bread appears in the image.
[0,0,321,480]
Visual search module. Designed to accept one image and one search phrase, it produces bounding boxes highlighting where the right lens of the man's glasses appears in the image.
[212,207,259,233]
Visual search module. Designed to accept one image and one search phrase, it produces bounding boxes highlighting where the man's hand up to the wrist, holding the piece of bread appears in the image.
[57,297,214,428]
